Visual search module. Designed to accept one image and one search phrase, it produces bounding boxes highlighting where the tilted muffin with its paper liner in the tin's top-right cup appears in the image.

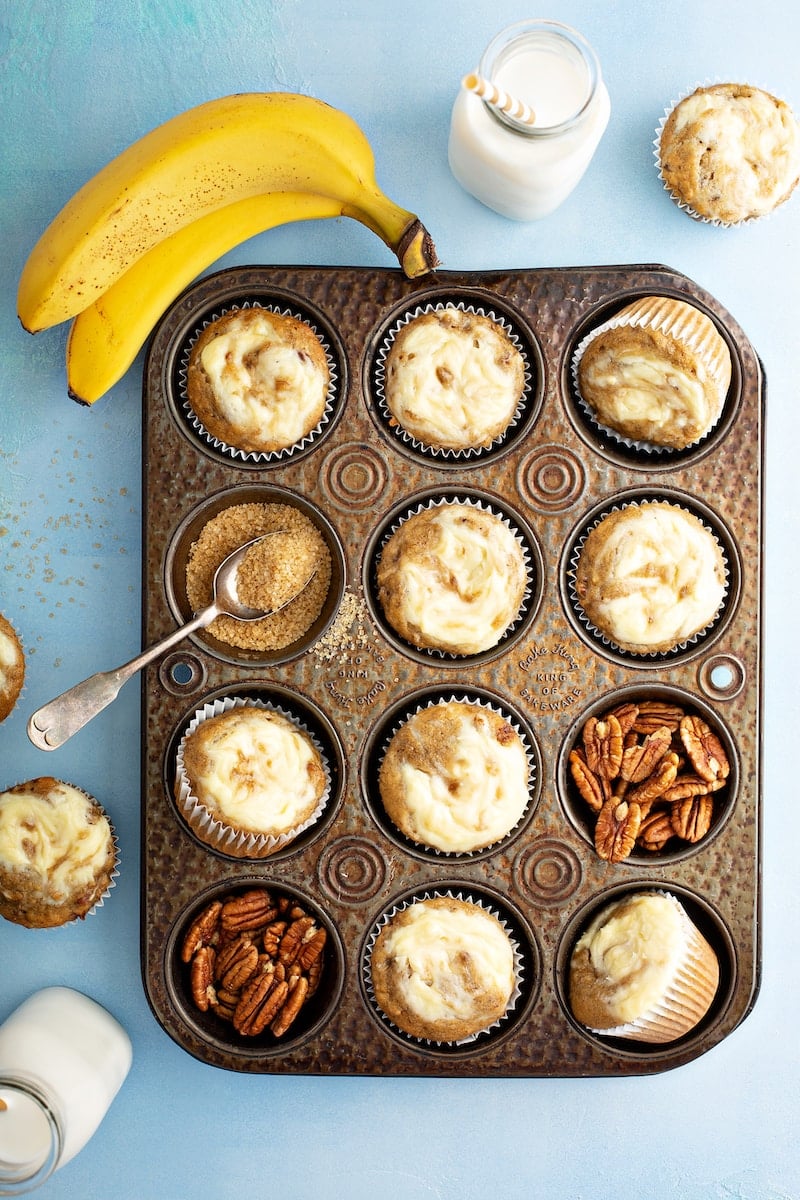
[577,296,730,450]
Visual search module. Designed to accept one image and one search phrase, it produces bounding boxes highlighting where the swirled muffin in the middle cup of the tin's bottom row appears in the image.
[371,895,516,1042]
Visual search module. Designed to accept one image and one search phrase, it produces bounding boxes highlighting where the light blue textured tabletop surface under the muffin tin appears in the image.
[0,0,800,1200]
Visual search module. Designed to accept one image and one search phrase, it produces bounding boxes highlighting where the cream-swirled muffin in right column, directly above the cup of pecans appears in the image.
[575,500,727,654]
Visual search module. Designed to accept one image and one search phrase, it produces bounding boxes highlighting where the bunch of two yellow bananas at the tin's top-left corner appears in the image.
[17,92,437,404]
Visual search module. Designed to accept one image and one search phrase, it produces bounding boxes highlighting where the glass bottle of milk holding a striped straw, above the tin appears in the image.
[449,20,610,221]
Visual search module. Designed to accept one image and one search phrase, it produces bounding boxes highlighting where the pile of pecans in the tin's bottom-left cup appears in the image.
[181,888,326,1038]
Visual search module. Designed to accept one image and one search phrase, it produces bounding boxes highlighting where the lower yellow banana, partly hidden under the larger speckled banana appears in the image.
[67,192,343,404]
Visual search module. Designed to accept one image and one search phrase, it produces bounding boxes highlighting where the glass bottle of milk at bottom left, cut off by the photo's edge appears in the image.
[0,988,131,1195]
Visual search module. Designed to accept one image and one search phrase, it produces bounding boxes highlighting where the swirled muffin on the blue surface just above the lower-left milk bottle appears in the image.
[0,776,116,929]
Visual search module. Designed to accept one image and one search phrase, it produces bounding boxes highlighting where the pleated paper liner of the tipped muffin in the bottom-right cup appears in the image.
[591,892,720,1044]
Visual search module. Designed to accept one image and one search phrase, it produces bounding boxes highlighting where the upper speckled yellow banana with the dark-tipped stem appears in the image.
[17,92,437,332]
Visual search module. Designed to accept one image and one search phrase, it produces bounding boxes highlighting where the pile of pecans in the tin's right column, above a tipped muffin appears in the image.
[570,700,730,863]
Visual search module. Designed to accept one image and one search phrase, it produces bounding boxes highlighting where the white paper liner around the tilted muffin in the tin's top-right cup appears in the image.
[570,295,730,457]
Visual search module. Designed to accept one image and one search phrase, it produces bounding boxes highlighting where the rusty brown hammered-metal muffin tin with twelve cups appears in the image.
[142,265,765,1076]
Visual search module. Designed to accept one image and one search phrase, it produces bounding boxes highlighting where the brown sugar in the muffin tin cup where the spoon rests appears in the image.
[186,504,331,650]
